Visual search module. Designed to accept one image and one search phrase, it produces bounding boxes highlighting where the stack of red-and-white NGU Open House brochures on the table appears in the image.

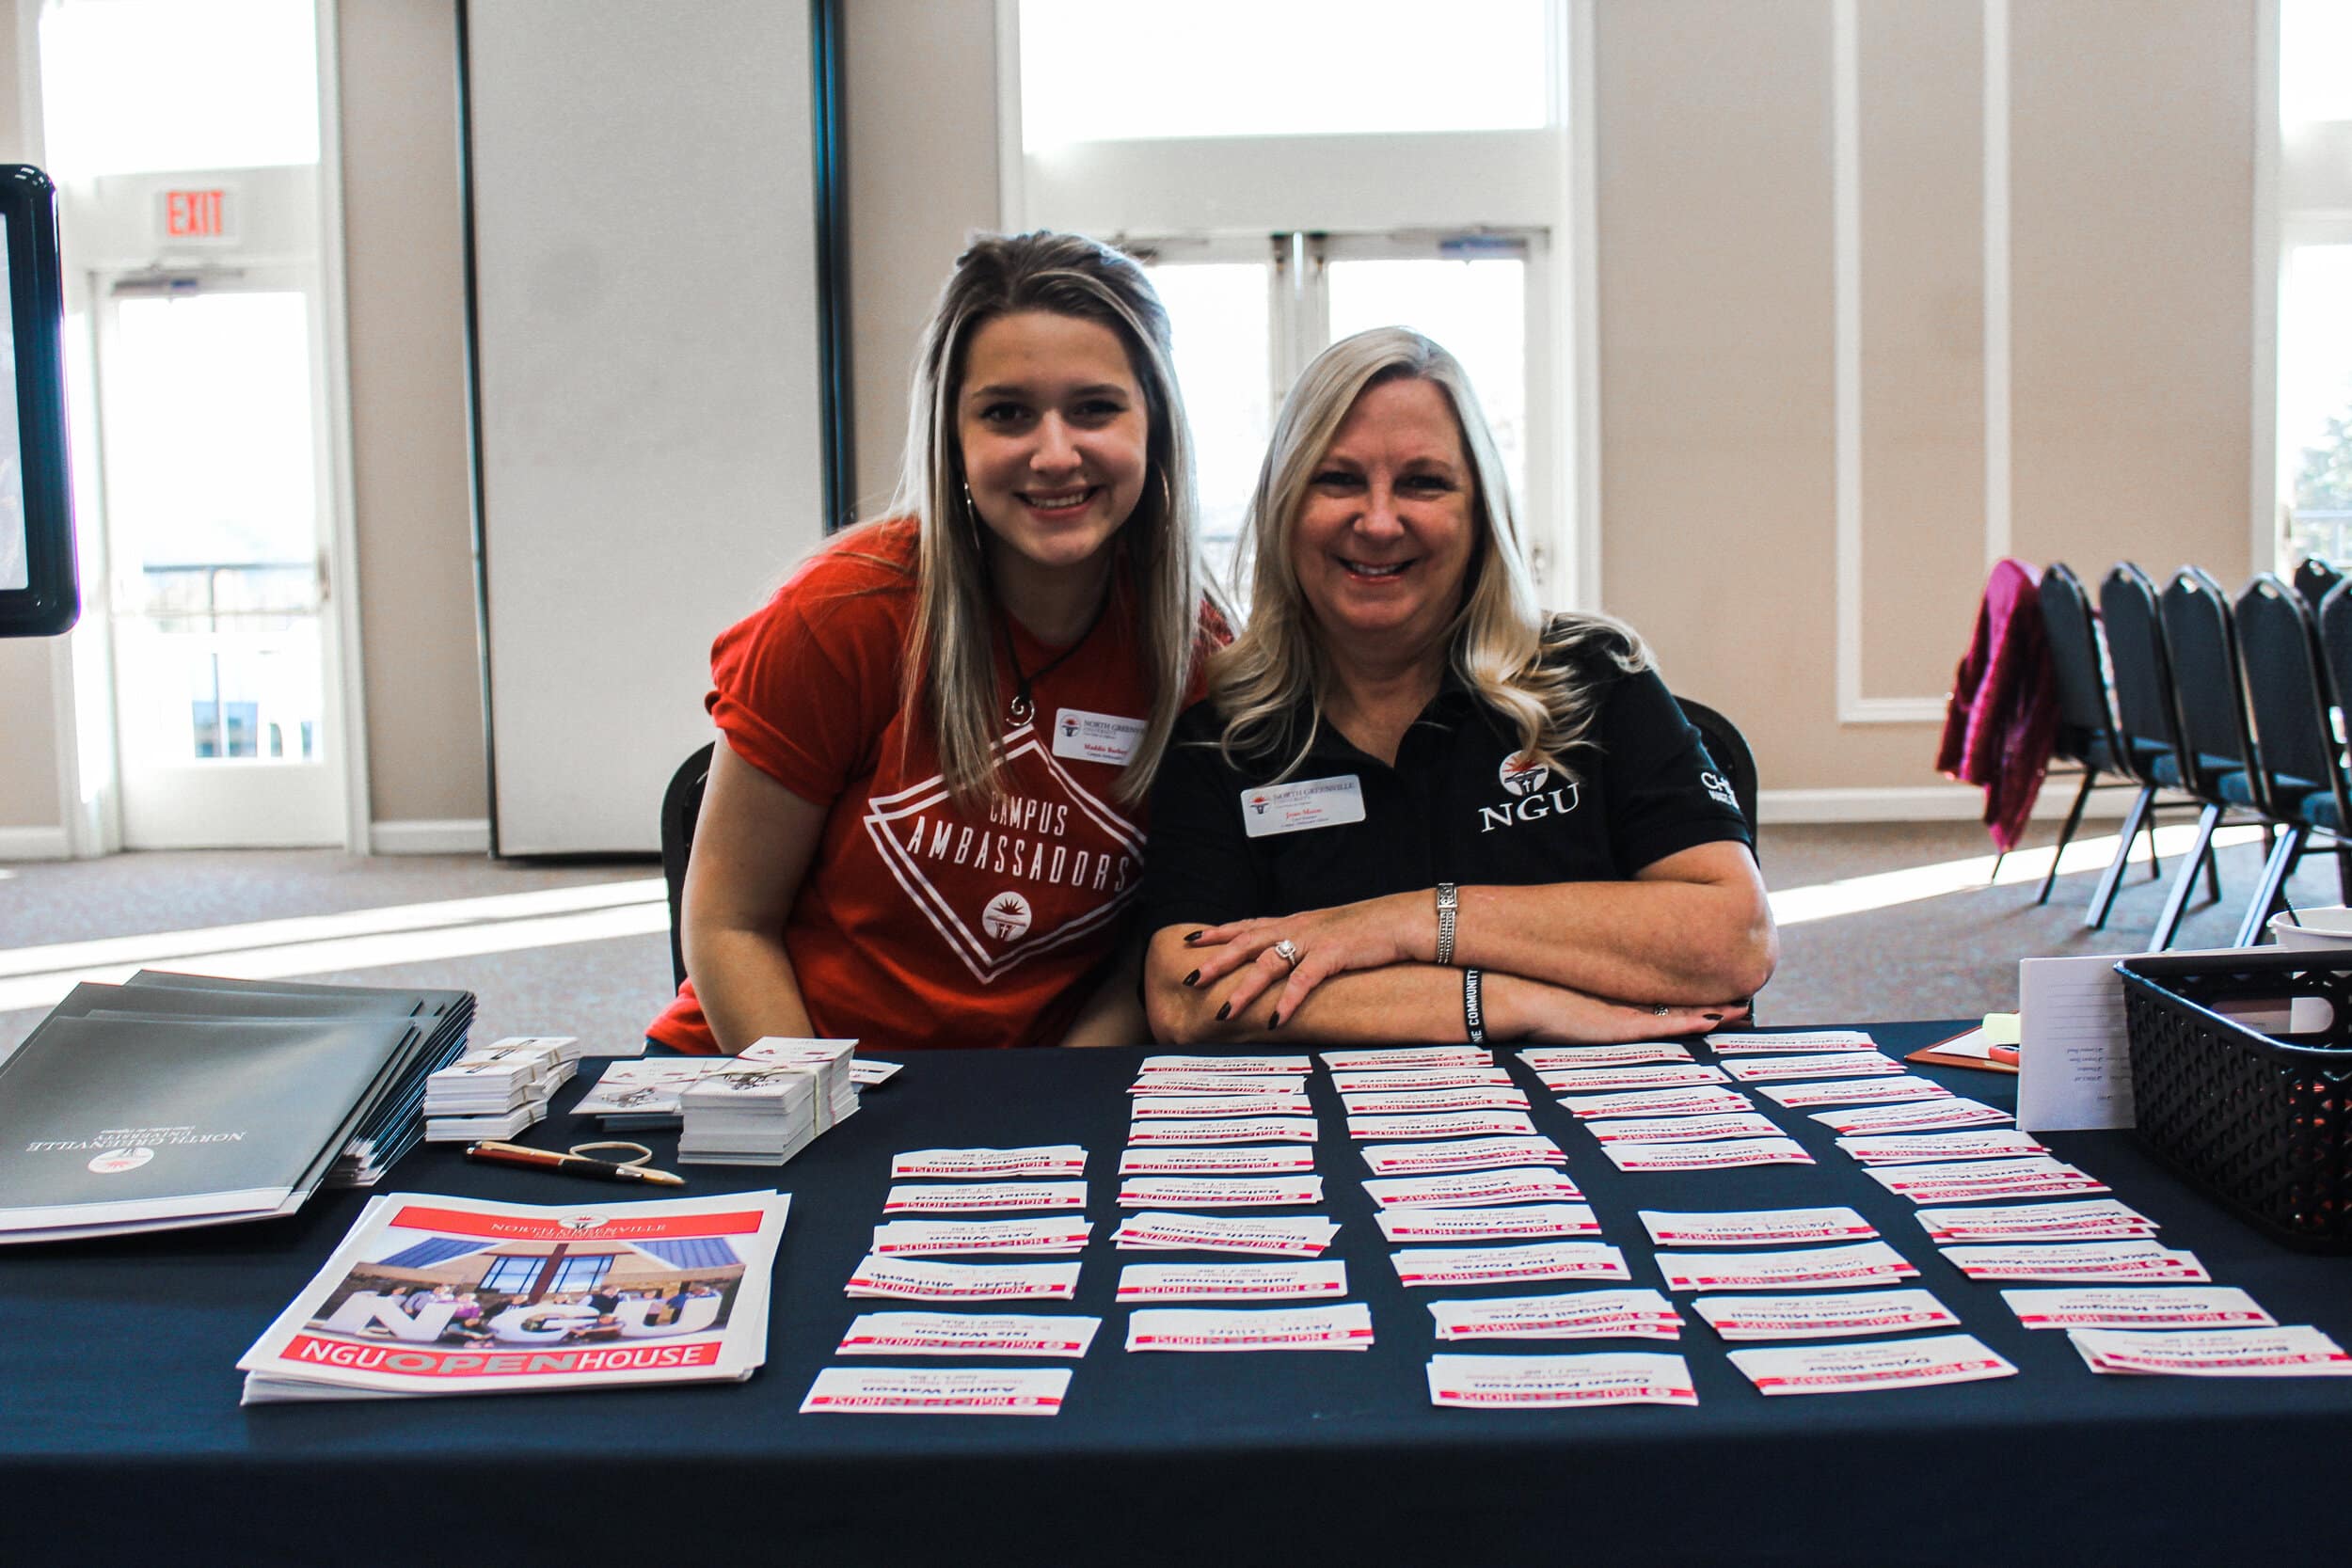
[238,1192,793,1403]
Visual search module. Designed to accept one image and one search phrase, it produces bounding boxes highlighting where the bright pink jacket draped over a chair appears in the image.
[1936,560,2058,853]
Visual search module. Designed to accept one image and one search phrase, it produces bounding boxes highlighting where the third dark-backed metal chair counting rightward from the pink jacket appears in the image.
[2153,566,2277,952]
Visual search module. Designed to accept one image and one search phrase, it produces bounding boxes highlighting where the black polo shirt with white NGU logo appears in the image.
[1143,665,1753,931]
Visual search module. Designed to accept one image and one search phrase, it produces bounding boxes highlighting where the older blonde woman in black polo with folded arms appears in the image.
[1143,329,1778,1041]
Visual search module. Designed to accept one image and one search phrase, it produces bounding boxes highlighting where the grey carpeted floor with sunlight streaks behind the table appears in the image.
[0,823,2341,1051]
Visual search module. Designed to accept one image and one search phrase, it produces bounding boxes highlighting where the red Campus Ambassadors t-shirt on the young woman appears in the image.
[647,519,1198,1053]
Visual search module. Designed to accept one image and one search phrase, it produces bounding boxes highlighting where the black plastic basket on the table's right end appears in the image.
[2115,950,2352,1253]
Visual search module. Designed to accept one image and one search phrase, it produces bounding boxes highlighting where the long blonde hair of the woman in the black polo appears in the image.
[1209,326,1649,778]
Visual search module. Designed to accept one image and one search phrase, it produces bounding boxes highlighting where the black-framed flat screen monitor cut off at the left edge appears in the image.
[0,165,83,637]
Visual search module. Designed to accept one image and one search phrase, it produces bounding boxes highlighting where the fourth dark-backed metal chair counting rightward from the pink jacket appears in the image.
[2237,571,2352,947]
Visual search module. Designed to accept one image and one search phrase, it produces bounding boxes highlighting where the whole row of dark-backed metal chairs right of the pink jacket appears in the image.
[2037,560,2352,950]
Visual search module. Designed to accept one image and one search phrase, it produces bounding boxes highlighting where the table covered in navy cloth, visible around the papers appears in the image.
[0,1025,2352,1568]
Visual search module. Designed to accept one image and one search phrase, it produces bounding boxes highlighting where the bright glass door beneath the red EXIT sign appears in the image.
[99,270,343,848]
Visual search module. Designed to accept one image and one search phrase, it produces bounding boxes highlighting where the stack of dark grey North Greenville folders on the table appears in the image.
[0,971,473,1243]
